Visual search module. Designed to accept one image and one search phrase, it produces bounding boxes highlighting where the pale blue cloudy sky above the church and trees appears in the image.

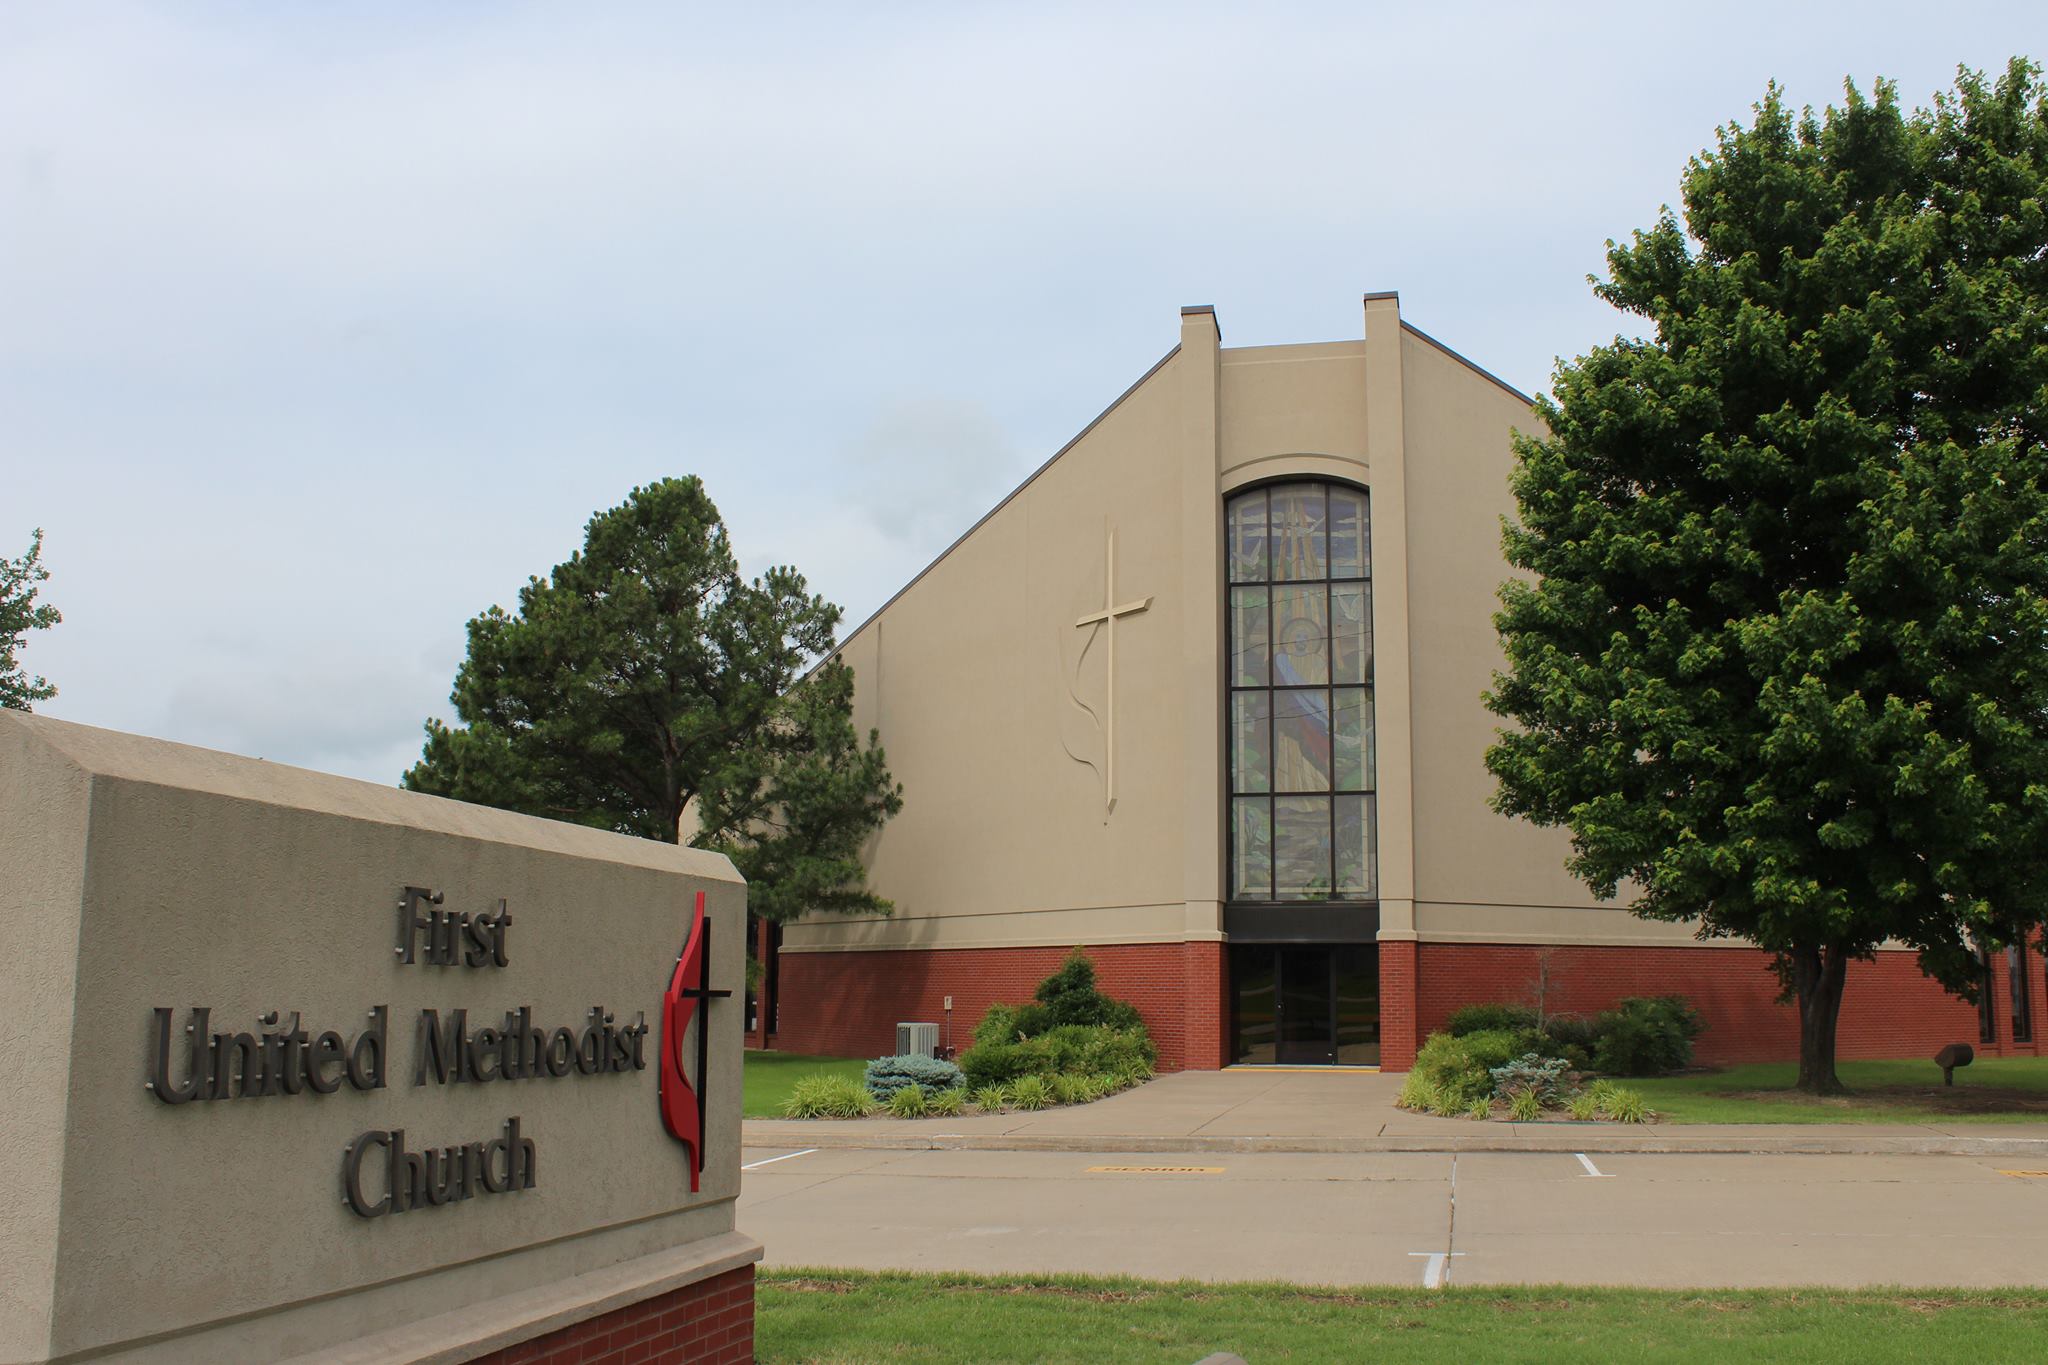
[0,0,2048,782]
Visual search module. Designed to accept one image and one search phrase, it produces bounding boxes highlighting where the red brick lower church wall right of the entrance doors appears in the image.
[1409,943,2044,1070]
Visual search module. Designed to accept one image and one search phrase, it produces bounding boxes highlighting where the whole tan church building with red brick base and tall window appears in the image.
[752,293,2048,1070]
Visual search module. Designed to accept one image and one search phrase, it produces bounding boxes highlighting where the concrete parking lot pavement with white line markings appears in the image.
[739,1148,2048,1287]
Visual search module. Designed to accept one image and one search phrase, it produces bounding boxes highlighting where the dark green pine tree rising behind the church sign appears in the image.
[403,477,903,921]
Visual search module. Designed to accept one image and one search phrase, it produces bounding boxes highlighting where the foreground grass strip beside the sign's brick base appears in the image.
[756,1271,2048,1365]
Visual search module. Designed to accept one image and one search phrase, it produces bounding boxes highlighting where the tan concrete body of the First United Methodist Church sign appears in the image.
[0,712,760,1363]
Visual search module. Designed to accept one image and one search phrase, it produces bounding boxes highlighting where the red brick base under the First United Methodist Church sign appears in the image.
[475,1265,754,1365]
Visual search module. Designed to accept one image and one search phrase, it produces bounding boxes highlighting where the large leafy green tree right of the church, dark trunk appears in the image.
[1487,59,2048,1093]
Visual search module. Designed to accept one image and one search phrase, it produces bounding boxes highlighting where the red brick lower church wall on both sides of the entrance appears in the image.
[770,941,2048,1070]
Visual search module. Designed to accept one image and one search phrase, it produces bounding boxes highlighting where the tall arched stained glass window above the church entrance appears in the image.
[1229,483,1378,902]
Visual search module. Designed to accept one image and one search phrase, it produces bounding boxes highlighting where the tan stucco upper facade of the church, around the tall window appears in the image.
[782,295,1690,970]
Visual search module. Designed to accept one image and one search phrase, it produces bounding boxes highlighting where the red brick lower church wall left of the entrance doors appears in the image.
[774,943,1229,1070]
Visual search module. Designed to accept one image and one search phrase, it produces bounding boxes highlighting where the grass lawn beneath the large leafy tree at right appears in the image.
[1622,1056,2048,1124]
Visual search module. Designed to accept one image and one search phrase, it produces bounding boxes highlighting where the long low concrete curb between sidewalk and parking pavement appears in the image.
[741,1121,2048,1156]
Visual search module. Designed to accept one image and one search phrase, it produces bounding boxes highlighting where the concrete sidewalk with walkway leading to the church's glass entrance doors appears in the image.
[743,1068,2048,1169]
